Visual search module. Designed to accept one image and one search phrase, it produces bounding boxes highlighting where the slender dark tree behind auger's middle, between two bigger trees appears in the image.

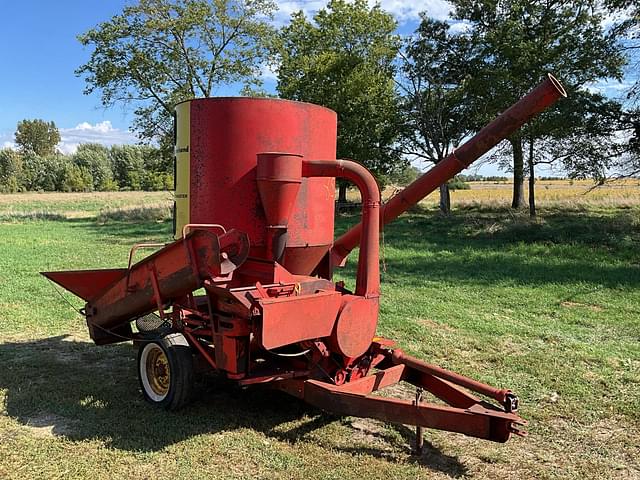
[399,14,475,214]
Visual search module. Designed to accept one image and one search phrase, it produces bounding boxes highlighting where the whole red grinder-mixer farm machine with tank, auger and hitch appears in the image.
[44,75,565,442]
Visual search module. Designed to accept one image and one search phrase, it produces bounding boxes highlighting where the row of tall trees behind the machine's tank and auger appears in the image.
[10,0,640,215]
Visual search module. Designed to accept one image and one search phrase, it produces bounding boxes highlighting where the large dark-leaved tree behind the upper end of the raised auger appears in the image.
[453,0,625,214]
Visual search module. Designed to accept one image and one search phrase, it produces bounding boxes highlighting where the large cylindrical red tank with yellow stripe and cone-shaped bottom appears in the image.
[175,98,337,274]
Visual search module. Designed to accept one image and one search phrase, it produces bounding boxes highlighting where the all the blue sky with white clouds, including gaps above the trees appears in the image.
[0,0,623,174]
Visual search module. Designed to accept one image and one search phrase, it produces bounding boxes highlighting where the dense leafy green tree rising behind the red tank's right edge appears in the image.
[277,0,404,201]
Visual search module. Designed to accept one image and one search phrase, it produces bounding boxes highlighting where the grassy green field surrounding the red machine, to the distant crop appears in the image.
[0,181,640,480]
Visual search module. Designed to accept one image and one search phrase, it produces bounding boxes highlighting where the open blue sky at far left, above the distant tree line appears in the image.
[0,0,139,151]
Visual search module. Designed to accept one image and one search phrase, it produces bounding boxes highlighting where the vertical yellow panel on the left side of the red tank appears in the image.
[174,101,191,239]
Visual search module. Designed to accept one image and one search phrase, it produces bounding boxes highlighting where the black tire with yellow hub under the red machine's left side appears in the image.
[138,333,194,410]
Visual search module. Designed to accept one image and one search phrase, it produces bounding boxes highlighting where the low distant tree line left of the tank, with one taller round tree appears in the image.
[0,119,173,193]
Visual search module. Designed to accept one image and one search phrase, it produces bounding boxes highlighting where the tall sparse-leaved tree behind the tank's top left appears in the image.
[76,0,275,144]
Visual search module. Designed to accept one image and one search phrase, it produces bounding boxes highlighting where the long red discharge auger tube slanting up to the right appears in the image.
[331,74,567,266]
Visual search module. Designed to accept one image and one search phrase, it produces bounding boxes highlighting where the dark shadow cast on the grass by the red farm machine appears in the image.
[0,335,466,477]
